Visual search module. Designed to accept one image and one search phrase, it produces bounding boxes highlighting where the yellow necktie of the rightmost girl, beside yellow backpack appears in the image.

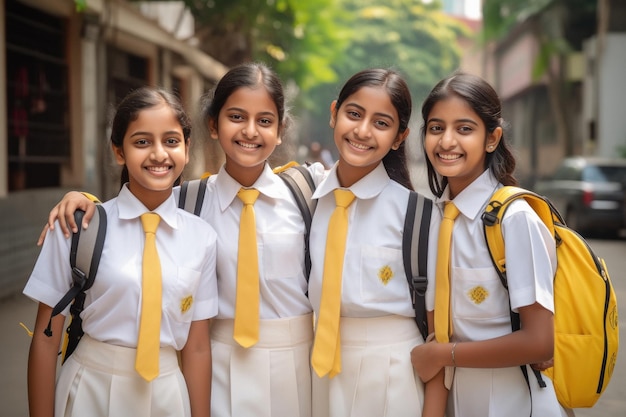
[435,201,459,343]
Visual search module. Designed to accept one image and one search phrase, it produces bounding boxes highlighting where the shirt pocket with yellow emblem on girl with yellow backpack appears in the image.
[452,267,510,320]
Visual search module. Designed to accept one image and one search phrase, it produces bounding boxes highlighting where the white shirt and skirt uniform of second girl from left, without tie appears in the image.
[189,164,324,417]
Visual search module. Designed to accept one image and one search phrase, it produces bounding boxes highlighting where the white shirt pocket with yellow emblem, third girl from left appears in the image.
[360,245,409,303]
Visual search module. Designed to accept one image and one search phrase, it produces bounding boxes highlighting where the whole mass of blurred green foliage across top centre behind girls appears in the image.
[134,0,467,148]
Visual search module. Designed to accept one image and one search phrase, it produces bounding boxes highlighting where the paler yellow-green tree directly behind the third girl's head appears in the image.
[302,0,469,145]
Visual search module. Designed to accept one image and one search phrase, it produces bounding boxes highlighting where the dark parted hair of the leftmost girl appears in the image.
[111,86,191,186]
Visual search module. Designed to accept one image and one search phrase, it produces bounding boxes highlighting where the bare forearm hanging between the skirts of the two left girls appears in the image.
[181,319,212,417]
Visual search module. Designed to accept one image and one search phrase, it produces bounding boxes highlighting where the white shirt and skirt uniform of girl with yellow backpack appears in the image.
[427,170,566,417]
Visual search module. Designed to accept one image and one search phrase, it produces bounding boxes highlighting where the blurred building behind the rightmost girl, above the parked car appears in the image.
[484,0,626,187]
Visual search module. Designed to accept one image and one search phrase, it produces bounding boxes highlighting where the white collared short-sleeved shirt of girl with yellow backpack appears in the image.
[426,170,556,341]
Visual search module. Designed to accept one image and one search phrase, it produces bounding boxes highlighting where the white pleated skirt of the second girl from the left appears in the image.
[211,314,313,417]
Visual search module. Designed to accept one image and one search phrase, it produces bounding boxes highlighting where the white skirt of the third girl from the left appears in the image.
[312,315,424,417]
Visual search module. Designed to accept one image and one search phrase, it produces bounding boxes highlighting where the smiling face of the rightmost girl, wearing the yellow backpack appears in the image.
[424,96,502,198]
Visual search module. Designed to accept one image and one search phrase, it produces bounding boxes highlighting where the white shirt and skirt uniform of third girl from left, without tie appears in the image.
[309,163,438,417]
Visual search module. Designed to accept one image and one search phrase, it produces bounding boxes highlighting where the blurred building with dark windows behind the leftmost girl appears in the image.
[0,0,227,296]
